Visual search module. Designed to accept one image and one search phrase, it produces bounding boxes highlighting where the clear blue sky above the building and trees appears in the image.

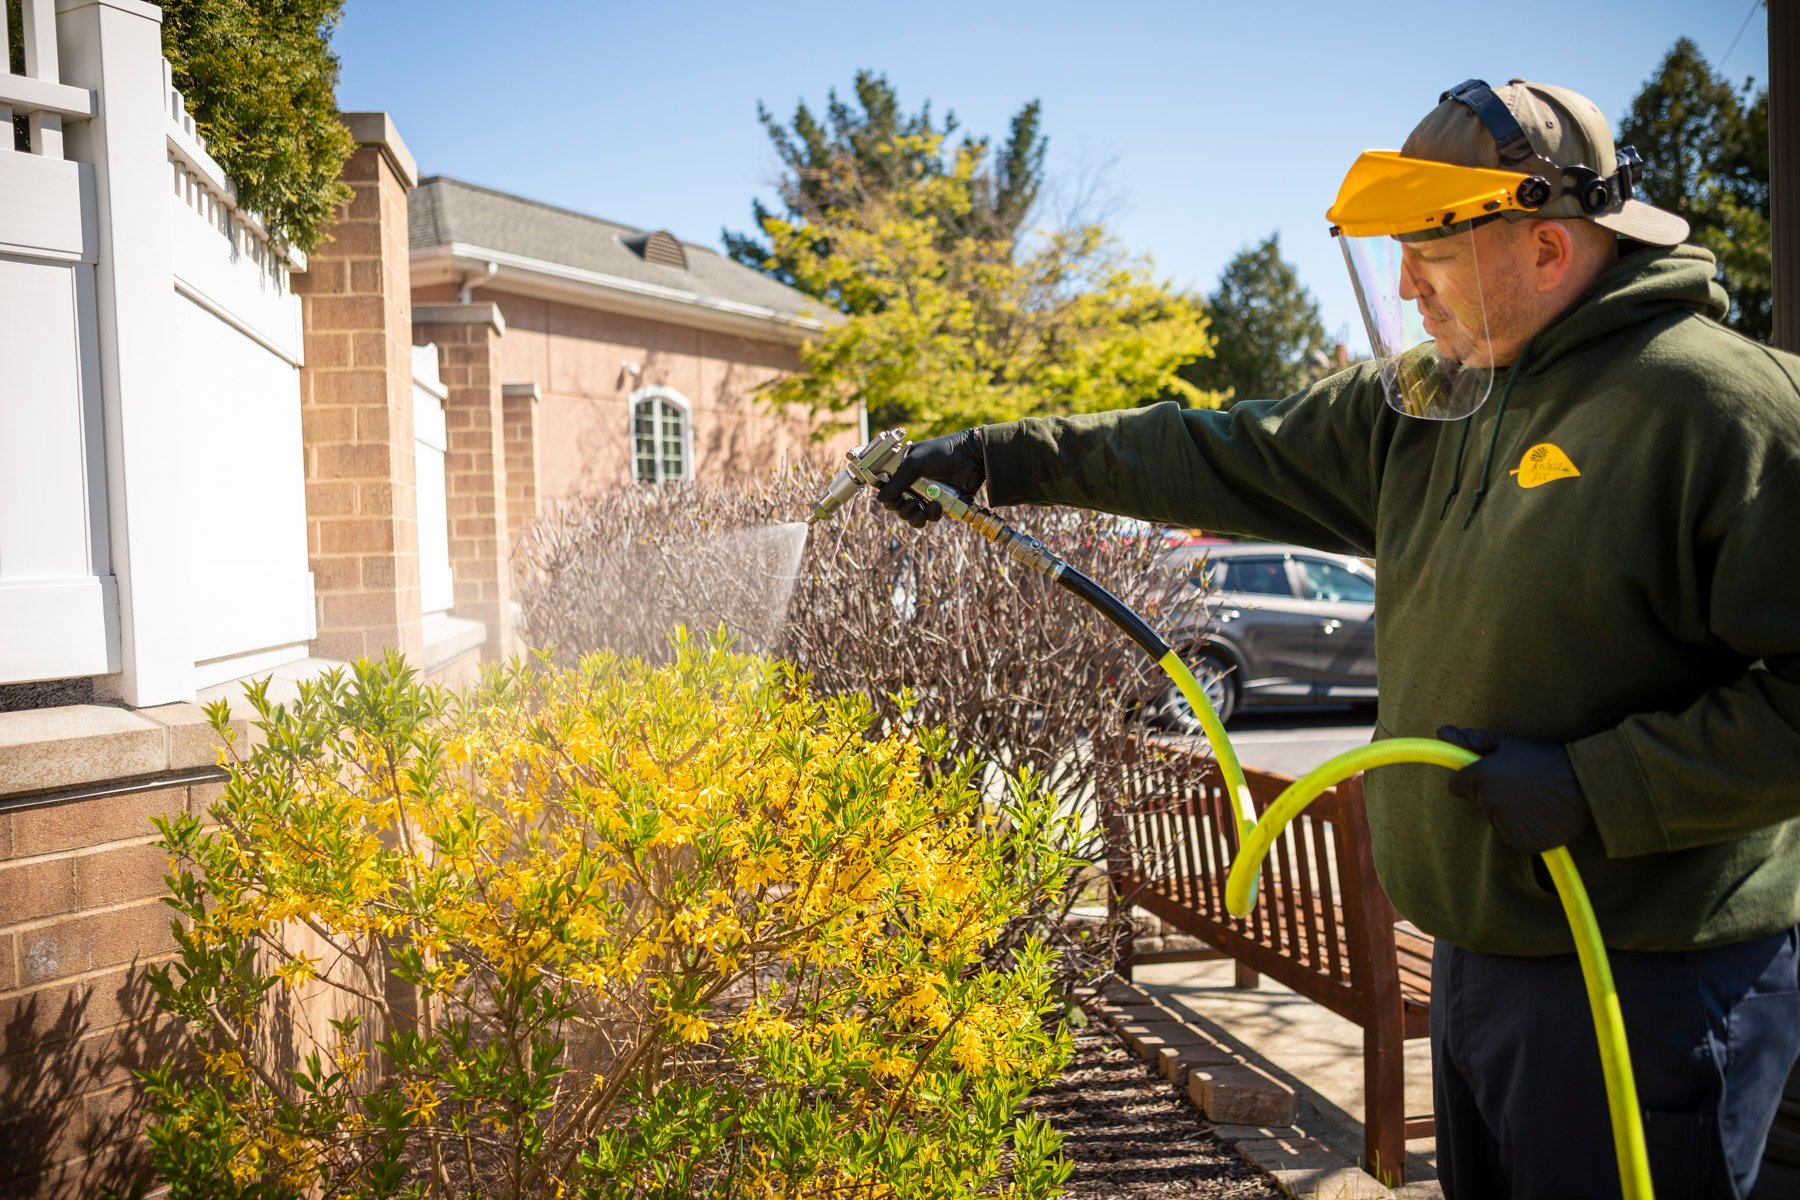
[335,0,1768,354]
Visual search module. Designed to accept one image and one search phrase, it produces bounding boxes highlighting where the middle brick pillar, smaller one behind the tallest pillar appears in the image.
[412,304,513,660]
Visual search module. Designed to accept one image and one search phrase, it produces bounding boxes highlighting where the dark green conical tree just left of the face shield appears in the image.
[1181,234,1334,399]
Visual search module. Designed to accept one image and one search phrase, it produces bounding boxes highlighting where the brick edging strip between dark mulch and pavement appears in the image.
[1075,979,1395,1200]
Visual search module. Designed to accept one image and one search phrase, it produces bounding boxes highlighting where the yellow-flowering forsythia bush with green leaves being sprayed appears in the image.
[148,637,1073,1200]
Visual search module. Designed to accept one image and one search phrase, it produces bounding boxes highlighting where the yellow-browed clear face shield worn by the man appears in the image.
[1327,149,1530,421]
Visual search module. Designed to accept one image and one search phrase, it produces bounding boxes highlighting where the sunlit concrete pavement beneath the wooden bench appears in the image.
[1132,959,1444,1200]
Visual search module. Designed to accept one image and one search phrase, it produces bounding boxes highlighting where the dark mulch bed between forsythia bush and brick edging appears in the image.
[1028,1027,1283,1200]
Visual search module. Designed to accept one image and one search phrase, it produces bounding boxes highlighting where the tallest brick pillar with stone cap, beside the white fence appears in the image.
[293,113,425,662]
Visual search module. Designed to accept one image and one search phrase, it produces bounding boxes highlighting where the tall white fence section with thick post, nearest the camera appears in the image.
[0,0,313,705]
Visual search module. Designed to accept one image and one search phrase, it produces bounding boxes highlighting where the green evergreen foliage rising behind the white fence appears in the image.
[162,0,356,250]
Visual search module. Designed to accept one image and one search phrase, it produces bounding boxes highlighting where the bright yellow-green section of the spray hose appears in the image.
[1157,662,1654,1200]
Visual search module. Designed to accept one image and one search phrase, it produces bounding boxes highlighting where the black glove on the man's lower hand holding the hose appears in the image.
[1438,725,1593,855]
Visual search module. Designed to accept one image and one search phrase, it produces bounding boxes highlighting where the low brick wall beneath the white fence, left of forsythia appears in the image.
[0,783,200,1200]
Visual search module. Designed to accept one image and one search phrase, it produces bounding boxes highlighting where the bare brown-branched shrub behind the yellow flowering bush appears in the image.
[517,468,1199,977]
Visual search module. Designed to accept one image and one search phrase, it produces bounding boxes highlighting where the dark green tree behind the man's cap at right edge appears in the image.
[1618,38,1773,342]
